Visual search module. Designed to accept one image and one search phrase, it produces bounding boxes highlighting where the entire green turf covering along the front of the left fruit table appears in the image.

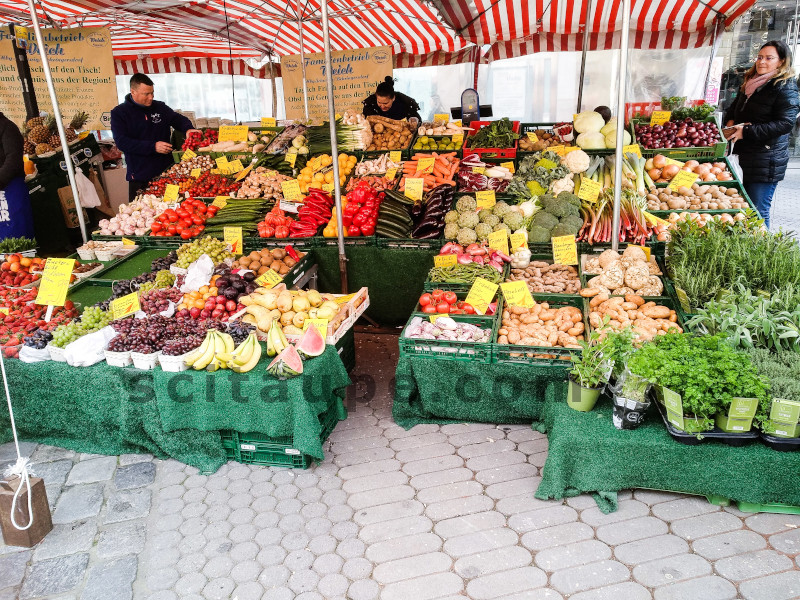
[0,346,350,473]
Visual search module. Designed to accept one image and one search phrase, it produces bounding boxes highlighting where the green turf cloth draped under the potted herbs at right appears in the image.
[536,396,800,512]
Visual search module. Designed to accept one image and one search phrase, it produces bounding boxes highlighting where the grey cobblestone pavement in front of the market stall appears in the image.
[0,335,800,600]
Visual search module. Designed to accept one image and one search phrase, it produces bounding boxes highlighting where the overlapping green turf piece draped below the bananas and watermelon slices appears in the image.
[153,346,350,460]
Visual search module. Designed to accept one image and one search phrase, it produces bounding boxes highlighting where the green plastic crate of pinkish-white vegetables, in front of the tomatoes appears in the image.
[399,312,497,364]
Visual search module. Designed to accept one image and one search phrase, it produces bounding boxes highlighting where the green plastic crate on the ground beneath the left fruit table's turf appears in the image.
[219,396,341,469]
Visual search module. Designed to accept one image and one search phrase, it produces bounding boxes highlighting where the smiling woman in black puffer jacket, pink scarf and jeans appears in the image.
[723,40,800,227]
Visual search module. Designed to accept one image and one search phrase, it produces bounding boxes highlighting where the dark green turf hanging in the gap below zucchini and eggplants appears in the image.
[313,246,437,326]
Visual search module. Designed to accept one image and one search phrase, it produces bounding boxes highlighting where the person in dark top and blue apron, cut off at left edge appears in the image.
[0,113,34,240]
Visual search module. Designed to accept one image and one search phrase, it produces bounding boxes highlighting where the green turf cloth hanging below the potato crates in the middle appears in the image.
[392,356,567,429]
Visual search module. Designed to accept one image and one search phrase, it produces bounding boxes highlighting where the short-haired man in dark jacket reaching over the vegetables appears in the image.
[111,73,195,200]
